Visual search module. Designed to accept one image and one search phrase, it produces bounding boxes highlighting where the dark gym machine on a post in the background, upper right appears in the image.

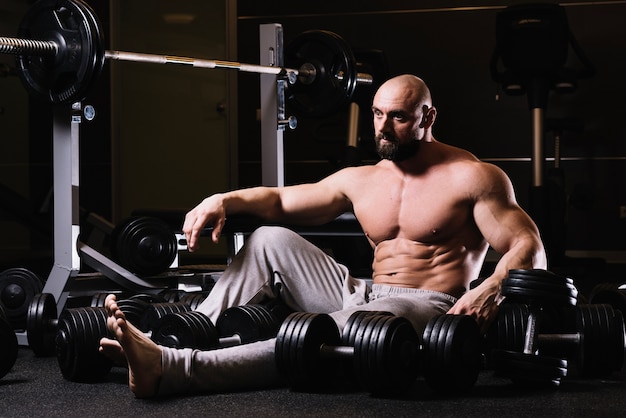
[490,3,595,261]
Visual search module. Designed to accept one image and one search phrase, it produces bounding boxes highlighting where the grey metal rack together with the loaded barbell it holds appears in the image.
[0,0,373,345]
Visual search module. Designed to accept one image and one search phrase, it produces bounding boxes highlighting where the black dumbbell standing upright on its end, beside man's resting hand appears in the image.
[491,269,578,386]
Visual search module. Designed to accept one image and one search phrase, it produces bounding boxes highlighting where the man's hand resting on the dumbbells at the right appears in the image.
[448,278,501,334]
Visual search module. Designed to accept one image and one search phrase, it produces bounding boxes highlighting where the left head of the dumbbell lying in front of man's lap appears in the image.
[275,312,341,391]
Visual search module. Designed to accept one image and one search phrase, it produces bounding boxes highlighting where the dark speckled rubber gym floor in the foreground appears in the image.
[0,348,626,417]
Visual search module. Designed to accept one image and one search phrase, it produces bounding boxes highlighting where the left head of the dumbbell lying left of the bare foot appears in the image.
[26,293,57,357]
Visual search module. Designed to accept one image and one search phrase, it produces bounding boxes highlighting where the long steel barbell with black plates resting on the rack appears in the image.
[0,0,373,116]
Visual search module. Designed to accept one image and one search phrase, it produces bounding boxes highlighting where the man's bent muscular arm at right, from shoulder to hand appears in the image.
[449,164,547,332]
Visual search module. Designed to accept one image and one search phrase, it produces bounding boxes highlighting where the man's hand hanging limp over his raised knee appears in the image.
[183,195,226,252]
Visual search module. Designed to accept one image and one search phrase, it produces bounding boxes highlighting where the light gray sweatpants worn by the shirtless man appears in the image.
[159,227,456,394]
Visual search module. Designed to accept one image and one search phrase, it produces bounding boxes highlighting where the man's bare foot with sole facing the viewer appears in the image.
[104,295,162,398]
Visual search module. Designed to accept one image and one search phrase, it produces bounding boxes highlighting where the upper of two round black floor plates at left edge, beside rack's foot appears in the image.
[0,267,43,329]
